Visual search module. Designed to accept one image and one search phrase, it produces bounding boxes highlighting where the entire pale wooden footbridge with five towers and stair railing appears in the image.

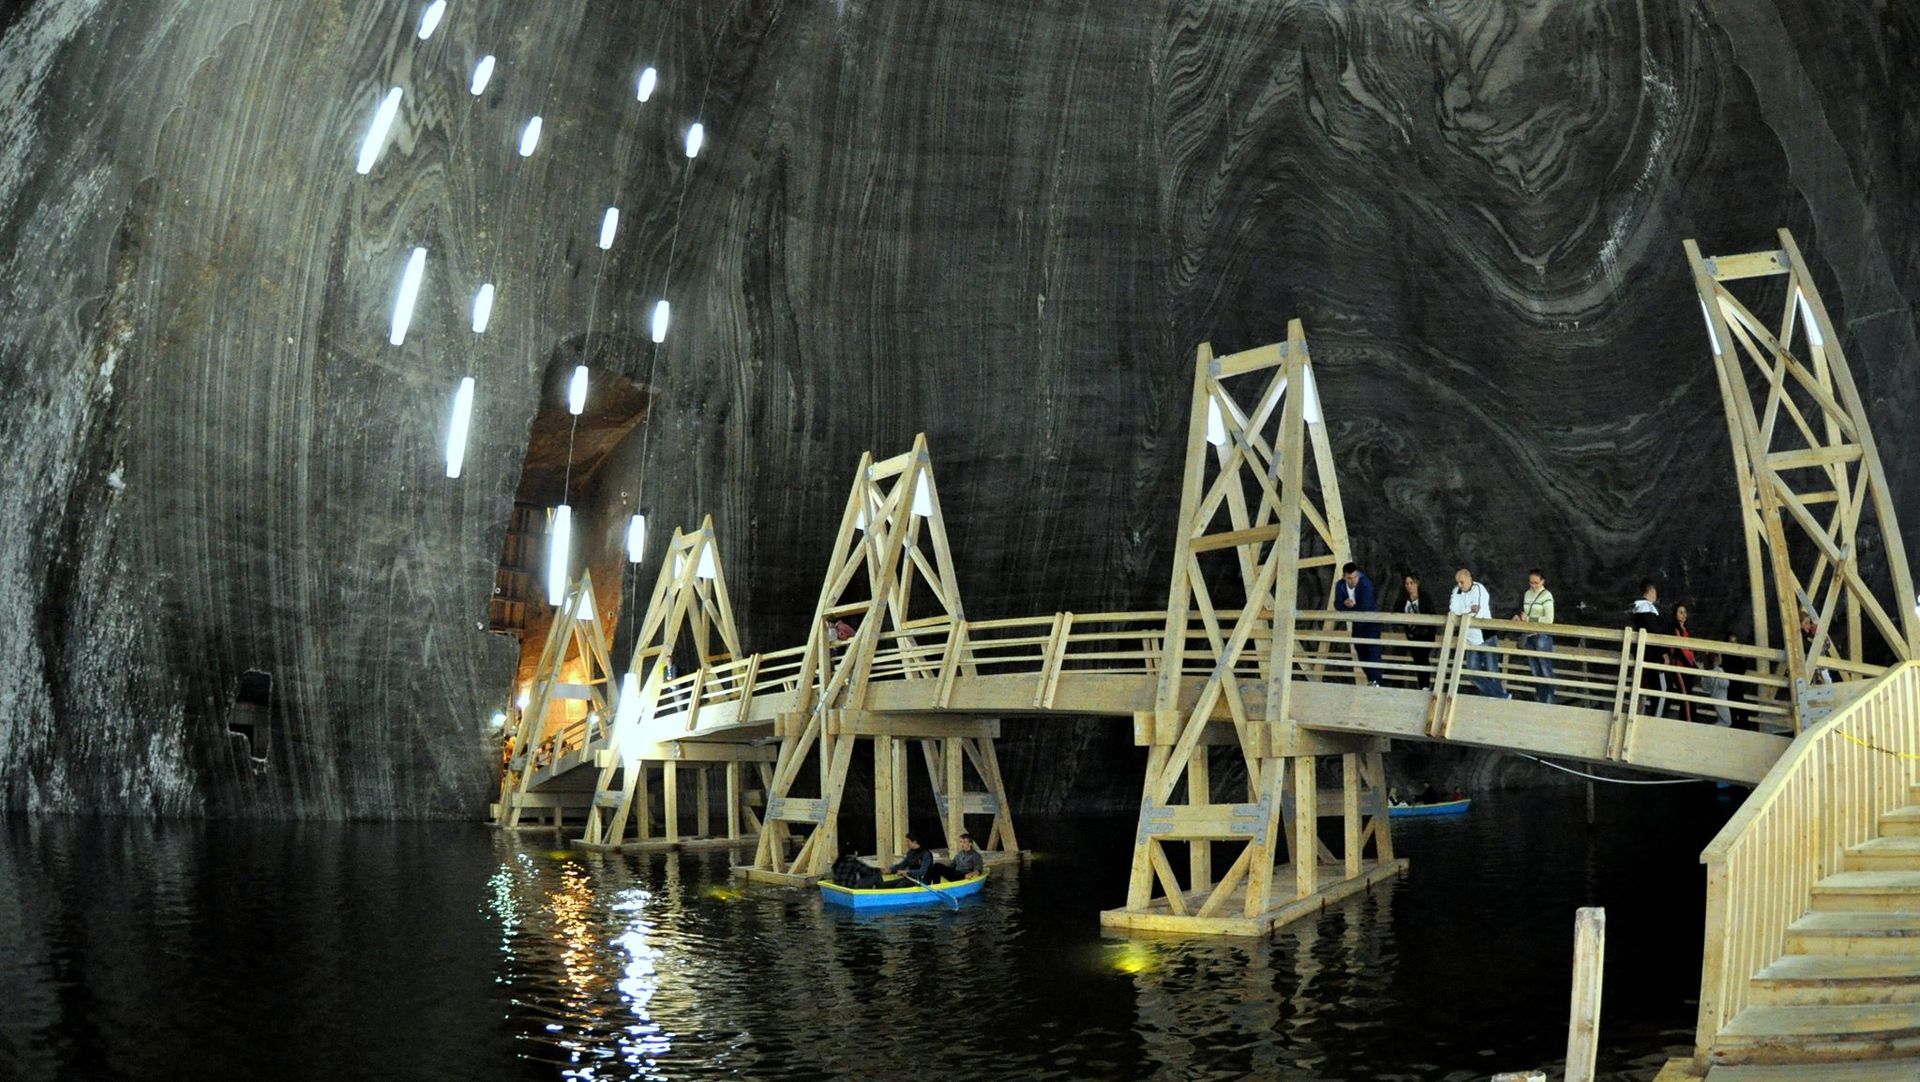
[495,230,1920,1063]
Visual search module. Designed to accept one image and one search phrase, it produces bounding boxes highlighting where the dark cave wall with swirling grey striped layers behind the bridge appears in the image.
[0,0,1920,817]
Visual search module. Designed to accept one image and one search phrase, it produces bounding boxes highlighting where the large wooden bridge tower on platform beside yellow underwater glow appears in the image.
[1100,320,1405,934]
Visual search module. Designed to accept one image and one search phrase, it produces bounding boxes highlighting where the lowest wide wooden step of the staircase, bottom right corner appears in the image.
[1715,1003,1920,1063]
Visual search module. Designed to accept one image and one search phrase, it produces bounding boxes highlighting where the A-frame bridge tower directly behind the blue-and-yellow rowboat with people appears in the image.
[741,434,1018,882]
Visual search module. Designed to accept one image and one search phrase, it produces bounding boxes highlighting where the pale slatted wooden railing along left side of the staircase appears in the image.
[1693,662,1920,1065]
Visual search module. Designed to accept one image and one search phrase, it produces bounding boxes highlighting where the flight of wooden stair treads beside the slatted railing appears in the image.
[1713,787,1920,1082]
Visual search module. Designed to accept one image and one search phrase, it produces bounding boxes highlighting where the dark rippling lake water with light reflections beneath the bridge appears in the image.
[0,785,1738,1080]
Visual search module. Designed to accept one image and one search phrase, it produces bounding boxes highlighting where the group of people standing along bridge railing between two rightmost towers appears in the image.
[1332,562,1734,725]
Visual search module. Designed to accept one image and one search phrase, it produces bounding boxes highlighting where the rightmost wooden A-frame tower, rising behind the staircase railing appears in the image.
[1686,230,1920,729]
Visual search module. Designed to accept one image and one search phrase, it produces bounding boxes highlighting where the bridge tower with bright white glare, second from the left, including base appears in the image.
[580,516,756,848]
